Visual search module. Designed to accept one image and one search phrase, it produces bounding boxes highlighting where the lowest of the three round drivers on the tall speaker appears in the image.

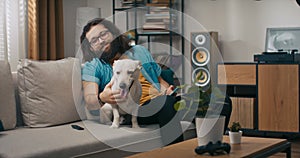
[192,67,210,87]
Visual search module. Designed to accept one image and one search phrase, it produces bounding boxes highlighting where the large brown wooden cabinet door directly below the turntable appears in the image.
[258,64,299,132]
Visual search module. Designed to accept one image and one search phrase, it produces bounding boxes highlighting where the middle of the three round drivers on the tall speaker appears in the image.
[192,47,210,66]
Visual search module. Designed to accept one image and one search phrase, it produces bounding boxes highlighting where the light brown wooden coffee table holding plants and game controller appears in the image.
[130,136,291,158]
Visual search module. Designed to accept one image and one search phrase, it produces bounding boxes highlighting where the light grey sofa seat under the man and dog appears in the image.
[0,120,195,158]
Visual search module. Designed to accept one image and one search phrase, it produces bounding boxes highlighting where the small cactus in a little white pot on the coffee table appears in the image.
[229,122,243,144]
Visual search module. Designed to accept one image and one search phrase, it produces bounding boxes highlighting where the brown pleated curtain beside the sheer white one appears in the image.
[28,0,64,60]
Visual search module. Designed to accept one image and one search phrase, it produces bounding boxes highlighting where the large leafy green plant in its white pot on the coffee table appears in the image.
[175,73,227,146]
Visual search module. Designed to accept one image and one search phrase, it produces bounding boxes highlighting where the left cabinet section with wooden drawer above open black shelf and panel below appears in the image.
[217,63,256,129]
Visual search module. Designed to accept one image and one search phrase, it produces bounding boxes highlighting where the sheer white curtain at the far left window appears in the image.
[0,0,27,71]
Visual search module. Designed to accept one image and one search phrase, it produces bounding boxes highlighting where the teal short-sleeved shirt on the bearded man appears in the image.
[82,45,161,92]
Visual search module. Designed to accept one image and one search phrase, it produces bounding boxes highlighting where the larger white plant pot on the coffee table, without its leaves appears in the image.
[195,116,225,146]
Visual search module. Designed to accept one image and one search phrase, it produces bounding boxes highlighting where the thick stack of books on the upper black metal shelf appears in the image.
[143,3,176,32]
